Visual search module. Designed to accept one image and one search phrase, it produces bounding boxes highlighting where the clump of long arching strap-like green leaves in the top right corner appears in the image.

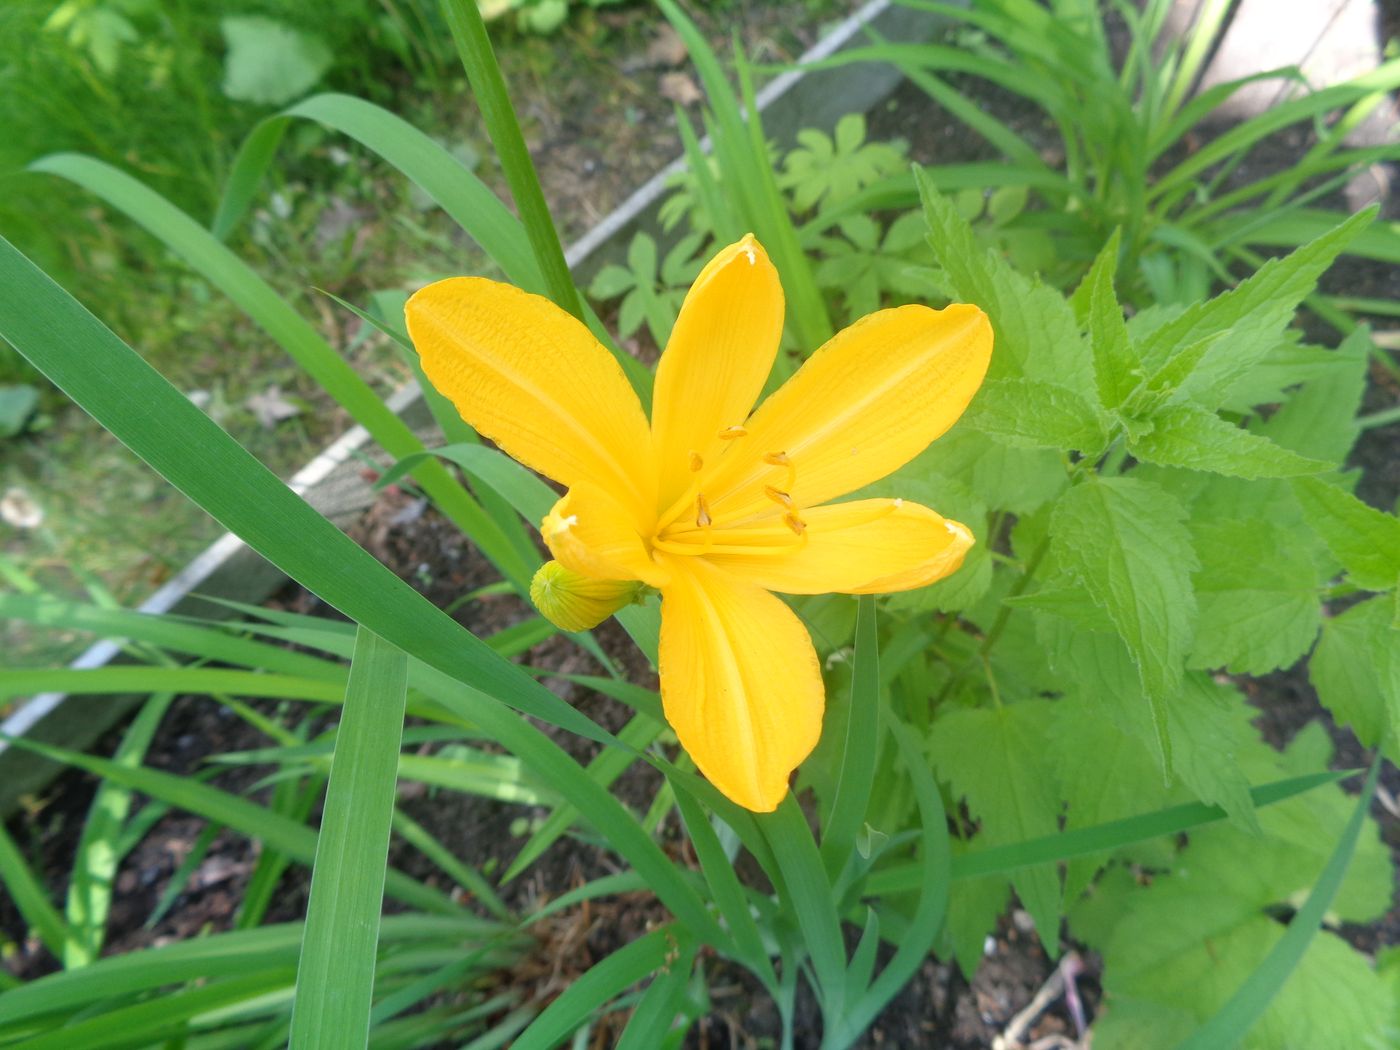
[806,0,1400,330]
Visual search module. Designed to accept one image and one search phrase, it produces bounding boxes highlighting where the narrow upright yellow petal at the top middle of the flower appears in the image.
[651,234,783,505]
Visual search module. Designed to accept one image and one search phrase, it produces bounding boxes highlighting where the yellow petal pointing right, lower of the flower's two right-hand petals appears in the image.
[706,500,974,594]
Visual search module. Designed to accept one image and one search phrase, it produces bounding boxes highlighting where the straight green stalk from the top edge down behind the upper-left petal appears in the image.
[442,0,584,319]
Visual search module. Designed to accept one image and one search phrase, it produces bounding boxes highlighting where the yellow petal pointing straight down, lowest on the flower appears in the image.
[659,559,825,813]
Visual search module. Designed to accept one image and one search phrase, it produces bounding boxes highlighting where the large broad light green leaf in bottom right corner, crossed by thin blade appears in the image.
[1102,756,1393,1050]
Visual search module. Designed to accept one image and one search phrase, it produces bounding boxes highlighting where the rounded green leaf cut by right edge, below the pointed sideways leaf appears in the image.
[1308,595,1400,748]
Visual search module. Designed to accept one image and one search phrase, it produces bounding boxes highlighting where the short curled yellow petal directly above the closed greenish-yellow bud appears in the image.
[539,482,671,587]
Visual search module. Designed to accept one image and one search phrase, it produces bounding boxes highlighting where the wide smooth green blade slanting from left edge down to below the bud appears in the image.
[0,241,612,742]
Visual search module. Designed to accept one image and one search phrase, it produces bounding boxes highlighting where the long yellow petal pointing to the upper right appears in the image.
[704,305,991,524]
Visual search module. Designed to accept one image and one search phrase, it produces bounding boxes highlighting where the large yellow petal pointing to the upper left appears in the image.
[405,277,657,526]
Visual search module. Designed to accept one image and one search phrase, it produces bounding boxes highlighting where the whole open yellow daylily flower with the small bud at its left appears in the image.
[406,235,991,812]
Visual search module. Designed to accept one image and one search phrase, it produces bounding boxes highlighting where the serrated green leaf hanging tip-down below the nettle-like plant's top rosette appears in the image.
[1051,477,1197,701]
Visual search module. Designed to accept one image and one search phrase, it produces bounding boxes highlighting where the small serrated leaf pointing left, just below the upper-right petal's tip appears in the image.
[965,378,1105,458]
